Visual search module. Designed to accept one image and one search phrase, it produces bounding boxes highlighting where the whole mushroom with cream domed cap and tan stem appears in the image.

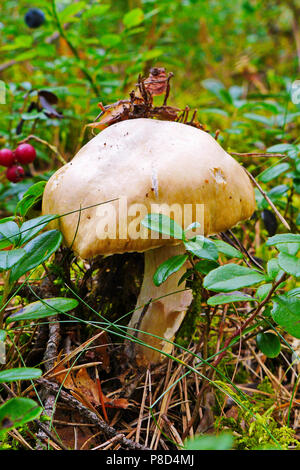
[42,118,255,363]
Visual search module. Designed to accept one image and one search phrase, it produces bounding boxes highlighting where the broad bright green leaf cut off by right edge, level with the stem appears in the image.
[271,295,300,339]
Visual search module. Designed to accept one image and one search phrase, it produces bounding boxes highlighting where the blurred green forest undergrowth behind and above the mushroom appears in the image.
[0,0,300,215]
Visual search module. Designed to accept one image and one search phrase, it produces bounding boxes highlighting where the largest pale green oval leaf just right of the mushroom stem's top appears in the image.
[203,264,265,292]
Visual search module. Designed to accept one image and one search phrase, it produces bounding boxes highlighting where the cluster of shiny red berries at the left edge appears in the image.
[0,144,36,183]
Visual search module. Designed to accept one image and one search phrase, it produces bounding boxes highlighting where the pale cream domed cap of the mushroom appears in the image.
[43,119,255,258]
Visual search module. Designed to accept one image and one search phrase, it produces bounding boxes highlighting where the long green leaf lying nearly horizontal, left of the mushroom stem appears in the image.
[6,297,78,323]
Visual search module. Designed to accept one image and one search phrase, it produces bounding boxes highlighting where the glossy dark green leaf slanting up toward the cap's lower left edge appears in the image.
[10,230,62,283]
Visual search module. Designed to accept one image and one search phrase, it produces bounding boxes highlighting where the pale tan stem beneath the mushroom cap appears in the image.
[128,244,192,363]
